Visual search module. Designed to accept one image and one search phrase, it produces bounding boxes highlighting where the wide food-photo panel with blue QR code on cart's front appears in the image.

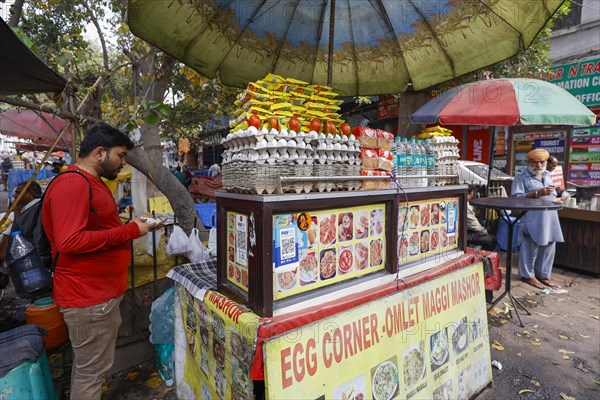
[273,204,386,300]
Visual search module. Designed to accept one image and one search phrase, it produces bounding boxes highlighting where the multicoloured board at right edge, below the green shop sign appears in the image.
[568,126,600,186]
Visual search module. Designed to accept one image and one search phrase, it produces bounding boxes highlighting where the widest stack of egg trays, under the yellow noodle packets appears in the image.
[221,127,360,194]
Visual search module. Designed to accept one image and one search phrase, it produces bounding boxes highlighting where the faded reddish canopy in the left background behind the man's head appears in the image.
[0,110,72,148]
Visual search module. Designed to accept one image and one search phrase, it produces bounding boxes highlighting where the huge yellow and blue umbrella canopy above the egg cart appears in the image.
[128,0,563,96]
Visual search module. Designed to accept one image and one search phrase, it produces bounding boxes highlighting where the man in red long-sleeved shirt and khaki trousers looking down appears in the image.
[42,124,157,400]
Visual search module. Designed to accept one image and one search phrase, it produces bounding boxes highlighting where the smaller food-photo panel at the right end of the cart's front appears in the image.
[396,197,459,265]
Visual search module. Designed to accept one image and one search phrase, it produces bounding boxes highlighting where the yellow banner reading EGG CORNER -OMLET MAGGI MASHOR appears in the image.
[265,263,492,400]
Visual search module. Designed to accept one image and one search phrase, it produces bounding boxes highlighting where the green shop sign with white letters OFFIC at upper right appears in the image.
[543,58,600,107]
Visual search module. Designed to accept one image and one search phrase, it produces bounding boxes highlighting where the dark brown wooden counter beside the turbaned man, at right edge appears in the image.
[554,208,600,275]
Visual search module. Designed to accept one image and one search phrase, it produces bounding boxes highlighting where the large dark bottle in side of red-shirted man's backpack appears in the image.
[7,231,52,297]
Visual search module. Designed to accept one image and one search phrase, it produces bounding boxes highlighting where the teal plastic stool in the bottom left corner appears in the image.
[0,352,56,400]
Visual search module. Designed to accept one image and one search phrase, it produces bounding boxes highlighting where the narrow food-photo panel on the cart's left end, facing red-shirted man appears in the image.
[227,211,248,292]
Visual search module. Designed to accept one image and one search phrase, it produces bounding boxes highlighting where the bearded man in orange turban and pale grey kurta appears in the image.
[512,149,563,289]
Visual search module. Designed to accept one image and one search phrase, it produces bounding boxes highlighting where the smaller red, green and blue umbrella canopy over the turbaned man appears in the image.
[410,78,596,126]
